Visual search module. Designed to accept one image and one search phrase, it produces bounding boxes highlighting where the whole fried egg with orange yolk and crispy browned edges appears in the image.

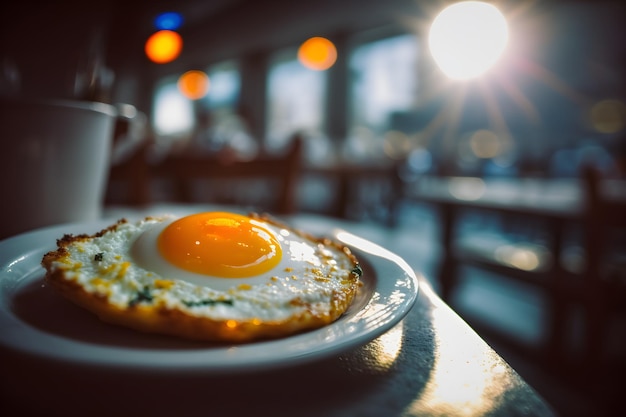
[42,212,362,342]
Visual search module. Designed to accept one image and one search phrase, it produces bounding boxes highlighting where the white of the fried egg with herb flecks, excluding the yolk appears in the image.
[48,217,355,321]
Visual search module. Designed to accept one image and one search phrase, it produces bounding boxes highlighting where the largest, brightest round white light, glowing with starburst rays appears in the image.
[428,1,508,80]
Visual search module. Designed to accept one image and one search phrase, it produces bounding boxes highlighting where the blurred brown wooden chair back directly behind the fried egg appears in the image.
[152,140,302,214]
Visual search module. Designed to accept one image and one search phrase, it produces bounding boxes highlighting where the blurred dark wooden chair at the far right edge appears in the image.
[581,167,626,370]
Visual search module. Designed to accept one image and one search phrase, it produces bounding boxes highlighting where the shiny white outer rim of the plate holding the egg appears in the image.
[0,219,419,375]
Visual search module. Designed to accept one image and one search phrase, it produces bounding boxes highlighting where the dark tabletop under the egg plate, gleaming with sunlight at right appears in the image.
[0,206,554,417]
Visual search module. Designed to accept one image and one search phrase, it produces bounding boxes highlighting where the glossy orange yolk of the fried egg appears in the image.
[157,212,282,278]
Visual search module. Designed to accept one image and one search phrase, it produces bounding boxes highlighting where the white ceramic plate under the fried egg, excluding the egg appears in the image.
[0,222,418,374]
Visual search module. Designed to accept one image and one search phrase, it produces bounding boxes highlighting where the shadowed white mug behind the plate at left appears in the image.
[0,98,117,239]
